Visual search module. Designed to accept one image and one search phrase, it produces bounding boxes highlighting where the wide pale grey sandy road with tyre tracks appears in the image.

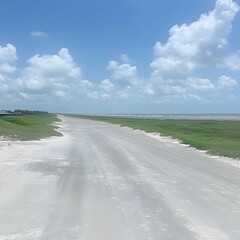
[0,117,240,240]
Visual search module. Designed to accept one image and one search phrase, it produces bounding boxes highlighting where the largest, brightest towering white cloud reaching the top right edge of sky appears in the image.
[151,0,239,72]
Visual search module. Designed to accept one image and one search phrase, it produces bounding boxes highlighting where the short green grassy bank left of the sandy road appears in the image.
[0,114,62,140]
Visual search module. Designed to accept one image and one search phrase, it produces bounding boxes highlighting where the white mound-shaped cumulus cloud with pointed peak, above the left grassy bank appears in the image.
[18,48,96,102]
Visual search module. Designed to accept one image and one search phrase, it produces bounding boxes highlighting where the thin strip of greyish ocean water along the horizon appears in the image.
[106,114,240,121]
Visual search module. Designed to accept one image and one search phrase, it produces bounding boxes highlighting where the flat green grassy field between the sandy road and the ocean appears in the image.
[68,115,240,158]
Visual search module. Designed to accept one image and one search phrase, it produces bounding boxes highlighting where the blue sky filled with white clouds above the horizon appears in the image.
[0,0,240,114]
